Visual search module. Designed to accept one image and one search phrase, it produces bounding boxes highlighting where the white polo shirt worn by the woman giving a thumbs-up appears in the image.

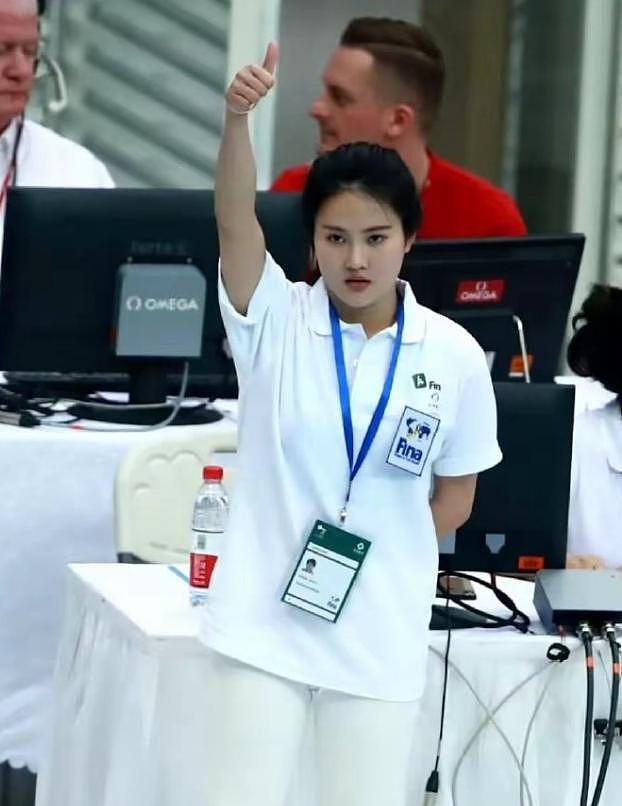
[202,255,501,701]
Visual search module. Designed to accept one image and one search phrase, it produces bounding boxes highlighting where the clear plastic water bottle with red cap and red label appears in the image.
[190,465,229,606]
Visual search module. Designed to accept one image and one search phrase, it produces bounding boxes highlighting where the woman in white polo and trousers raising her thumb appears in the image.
[202,44,501,806]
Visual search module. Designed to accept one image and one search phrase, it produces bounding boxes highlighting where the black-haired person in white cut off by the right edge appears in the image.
[567,285,622,570]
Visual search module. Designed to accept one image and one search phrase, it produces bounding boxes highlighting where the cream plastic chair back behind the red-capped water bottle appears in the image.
[114,425,237,563]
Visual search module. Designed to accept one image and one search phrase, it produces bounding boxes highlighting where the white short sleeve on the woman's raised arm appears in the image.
[218,252,293,385]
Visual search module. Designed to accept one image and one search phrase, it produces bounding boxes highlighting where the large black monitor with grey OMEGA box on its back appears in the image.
[0,188,308,426]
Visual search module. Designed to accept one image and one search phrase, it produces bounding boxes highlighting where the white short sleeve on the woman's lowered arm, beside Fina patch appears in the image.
[432,345,502,476]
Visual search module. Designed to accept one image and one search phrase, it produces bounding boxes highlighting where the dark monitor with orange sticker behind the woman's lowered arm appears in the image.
[439,383,574,573]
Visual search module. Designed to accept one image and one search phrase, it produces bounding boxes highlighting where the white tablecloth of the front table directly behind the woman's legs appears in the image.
[37,565,622,806]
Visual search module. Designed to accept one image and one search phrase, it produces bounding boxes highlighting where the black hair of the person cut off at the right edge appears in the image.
[567,285,622,395]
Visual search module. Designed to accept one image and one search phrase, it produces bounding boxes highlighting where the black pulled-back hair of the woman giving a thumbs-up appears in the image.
[302,143,421,244]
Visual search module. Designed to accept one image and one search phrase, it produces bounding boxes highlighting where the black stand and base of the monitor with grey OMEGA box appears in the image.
[67,363,222,426]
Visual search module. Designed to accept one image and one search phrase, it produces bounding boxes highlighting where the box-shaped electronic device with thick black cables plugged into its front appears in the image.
[533,569,622,633]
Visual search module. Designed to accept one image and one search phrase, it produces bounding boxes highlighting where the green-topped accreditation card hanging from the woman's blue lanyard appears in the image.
[281,521,371,622]
